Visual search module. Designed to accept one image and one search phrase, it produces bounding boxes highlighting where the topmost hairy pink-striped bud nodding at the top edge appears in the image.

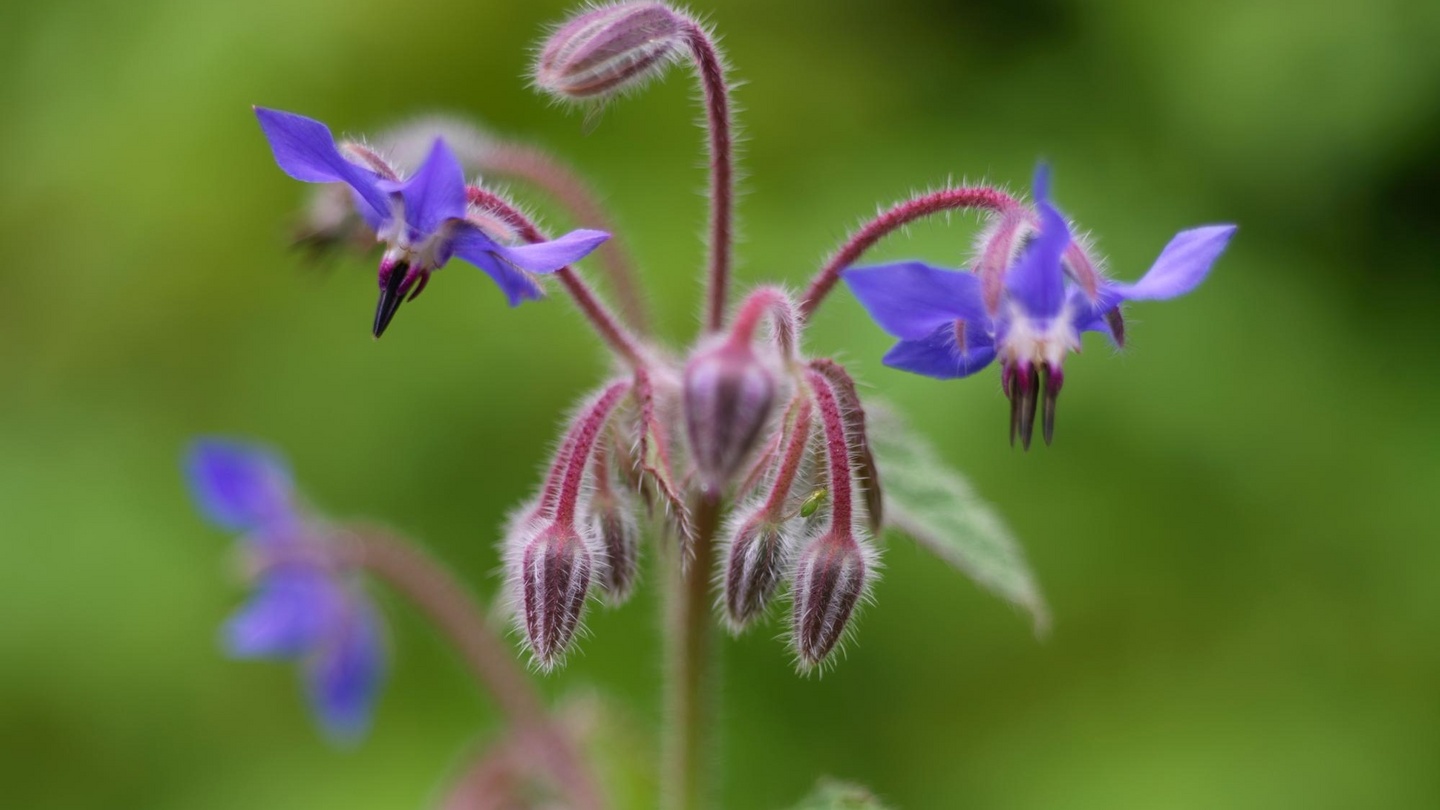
[534,3,685,101]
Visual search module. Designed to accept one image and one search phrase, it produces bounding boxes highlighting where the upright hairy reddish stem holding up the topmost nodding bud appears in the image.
[684,20,734,331]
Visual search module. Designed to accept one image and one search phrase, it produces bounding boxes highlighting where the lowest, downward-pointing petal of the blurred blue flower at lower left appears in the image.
[305,595,384,742]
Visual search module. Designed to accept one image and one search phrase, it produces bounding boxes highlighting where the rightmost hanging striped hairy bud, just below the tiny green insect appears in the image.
[792,530,870,669]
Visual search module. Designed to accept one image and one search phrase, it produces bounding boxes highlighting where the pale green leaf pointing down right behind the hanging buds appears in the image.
[867,399,1050,636]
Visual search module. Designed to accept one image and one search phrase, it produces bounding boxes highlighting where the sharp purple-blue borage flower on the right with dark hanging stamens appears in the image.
[844,160,1236,450]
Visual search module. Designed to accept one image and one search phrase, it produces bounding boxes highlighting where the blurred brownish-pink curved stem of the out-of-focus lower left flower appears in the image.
[340,528,605,810]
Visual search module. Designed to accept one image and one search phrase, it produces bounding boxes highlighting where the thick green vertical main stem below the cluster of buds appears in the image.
[661,493,720,810]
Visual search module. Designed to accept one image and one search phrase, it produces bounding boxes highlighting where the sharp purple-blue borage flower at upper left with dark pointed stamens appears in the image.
[255,107,611,337]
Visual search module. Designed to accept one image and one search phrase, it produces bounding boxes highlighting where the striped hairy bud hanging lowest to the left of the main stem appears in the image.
[518,523,593,669]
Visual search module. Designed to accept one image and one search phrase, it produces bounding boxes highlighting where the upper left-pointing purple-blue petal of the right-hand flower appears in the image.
[841,261,989,340]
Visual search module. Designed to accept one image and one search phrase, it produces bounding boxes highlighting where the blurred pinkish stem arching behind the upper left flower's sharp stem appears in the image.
[475,141,649,334]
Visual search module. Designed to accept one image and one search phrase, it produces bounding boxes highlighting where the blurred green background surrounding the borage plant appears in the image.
[0,0,1440,809]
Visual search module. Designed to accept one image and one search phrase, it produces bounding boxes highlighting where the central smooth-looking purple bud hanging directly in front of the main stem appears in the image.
[684,340,776,490]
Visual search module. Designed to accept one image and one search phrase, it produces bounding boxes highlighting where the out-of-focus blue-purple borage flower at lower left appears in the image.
[186,440,384,742]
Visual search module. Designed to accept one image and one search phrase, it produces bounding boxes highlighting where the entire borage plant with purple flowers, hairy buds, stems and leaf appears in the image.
[190,3,1234,809]
